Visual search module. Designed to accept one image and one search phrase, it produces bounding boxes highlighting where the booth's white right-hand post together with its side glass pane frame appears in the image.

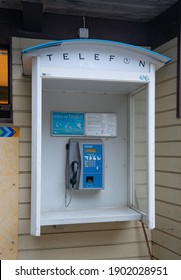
[129,64,155,229]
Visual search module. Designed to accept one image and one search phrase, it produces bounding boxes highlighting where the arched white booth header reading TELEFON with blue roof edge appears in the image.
[23,39,168,76]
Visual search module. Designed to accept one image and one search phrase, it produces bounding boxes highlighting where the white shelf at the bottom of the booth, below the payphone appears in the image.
[40,207,141,226]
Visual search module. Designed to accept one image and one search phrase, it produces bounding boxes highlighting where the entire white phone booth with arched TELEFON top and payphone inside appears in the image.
[22,39,170,236]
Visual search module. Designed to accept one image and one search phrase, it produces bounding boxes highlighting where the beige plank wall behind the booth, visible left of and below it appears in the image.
[13,38,150,259]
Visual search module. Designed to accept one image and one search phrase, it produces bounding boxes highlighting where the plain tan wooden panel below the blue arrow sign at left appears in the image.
[0,137,19,260]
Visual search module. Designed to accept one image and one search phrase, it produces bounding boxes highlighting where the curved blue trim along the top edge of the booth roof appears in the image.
[22,39,171,63]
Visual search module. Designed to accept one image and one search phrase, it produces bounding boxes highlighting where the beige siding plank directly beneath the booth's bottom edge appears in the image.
[19,228,151,250]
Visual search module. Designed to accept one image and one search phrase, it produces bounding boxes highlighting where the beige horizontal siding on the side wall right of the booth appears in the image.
[152,39,181,259]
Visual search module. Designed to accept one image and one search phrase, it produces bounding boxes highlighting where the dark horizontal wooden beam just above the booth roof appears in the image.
[0,9,148,46]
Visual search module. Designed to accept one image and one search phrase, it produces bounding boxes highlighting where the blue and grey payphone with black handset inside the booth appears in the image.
[66,139,104,190]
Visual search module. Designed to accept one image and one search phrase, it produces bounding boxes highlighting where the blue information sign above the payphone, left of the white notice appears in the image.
[52,112,84,136]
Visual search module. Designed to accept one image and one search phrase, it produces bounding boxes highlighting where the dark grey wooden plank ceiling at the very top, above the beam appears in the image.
[0,0,178,22]
